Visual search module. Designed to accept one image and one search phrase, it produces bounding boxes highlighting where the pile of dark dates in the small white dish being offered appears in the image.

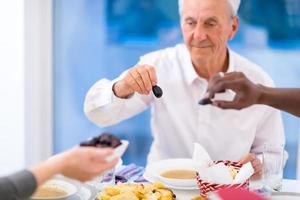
[80,133,122,148]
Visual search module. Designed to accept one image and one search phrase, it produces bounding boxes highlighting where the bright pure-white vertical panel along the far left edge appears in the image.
[0,0,25,175]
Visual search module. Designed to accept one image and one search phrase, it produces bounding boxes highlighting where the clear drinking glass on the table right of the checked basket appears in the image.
[263,143,284,191]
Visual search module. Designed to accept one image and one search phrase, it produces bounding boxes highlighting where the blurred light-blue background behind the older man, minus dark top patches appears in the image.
[54,0,300,178]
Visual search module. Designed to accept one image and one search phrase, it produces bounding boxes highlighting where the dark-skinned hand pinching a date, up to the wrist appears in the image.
[206,72,261,110]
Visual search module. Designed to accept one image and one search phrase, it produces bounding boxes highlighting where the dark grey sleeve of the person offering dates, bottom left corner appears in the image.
[0,170,37,200]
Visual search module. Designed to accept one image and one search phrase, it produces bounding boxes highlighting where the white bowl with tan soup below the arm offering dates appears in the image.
[30,179,78,200]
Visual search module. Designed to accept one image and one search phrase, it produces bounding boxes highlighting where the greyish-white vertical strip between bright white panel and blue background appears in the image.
[25,0,53,166]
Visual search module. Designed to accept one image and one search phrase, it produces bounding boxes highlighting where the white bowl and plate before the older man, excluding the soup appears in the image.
[144,158,199,190]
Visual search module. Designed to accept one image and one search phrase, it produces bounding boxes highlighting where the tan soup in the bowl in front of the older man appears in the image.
[160,169,197,179]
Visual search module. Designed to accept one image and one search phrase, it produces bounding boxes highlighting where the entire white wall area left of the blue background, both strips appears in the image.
[0,0,52,176]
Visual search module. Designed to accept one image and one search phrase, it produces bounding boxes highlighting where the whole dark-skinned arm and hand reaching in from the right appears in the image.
[206,72,300,117]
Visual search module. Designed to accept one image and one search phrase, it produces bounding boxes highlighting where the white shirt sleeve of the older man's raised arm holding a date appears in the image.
[84,72,153,126]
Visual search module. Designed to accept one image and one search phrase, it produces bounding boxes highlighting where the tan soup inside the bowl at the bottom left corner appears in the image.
[32,186,68,198]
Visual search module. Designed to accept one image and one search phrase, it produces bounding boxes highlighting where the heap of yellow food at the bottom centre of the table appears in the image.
[98,182,176,200]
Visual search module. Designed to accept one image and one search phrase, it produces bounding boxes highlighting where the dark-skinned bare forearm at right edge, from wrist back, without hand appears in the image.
[258,85,300,117]
